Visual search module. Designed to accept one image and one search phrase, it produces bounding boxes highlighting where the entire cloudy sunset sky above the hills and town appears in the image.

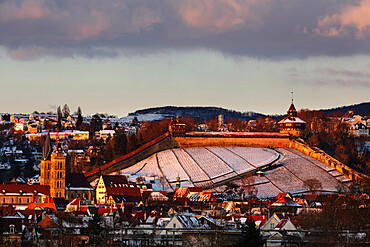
[0,0,370,117]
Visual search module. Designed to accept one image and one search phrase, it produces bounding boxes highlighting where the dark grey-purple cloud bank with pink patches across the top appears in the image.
[0,0,370,59]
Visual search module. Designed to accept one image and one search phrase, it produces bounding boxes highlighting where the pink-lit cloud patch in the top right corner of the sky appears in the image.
[316,0,370,39]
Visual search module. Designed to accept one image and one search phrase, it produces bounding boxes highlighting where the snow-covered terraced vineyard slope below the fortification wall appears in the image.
[115,147,350,198]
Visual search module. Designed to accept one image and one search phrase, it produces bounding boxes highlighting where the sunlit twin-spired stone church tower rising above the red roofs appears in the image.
[40,134,66,197]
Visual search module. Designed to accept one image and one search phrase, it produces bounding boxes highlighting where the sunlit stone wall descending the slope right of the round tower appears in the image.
[289,140,369,184]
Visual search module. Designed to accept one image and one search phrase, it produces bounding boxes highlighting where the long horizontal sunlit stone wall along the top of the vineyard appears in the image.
[175,137,289,148]
